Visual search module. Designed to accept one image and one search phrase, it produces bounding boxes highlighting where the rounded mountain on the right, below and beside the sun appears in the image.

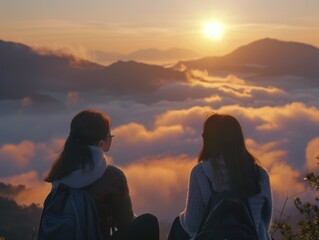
[175,38,319,77]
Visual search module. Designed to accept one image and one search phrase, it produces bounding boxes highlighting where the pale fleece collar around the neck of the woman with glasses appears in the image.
[52,146,107,188]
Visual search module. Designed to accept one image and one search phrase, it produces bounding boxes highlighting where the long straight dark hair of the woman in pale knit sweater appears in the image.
[198,114,261,197]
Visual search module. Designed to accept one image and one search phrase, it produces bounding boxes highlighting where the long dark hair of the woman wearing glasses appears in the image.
[45,109,111,182]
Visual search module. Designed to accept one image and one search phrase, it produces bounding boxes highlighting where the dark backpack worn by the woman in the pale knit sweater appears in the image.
[192,183,258,240]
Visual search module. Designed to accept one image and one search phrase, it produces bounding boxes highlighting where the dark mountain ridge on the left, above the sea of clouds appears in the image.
[0,41,186,103]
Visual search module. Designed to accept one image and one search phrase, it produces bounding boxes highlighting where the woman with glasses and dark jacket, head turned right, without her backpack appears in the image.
[45,110,159,240]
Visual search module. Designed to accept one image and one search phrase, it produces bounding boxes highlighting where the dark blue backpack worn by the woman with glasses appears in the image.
[38,184,102,240]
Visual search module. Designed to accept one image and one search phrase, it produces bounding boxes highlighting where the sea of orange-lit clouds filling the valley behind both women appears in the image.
[0,71,319,224]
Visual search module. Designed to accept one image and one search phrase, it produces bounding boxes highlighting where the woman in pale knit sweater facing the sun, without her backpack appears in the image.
[169,114,272,240]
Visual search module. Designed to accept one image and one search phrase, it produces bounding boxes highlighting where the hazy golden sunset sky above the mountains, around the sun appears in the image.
[0,0,319,55]
